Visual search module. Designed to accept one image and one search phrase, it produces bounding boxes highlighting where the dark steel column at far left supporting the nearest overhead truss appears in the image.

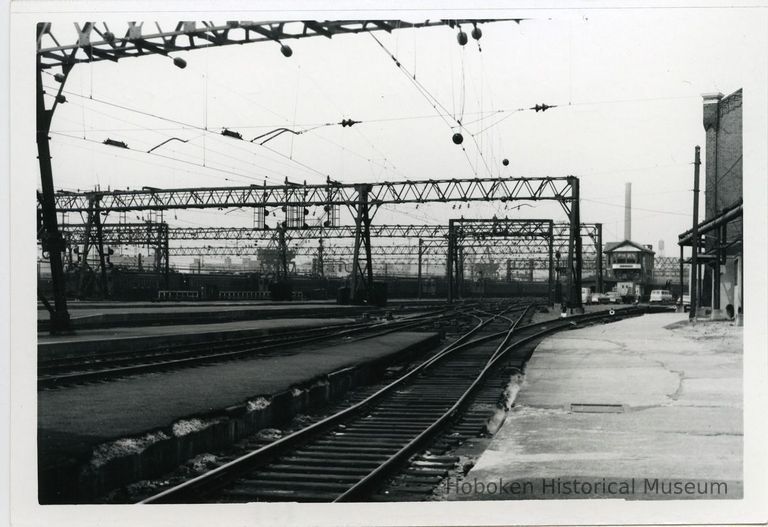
[35,23,72,333]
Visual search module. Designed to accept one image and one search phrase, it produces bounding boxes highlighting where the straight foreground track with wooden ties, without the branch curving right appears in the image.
[138,306,528,503]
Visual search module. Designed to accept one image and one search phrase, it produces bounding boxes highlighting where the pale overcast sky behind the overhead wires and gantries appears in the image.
[44,10,766,264]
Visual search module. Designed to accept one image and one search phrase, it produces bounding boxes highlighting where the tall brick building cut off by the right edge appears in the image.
[678,90,744,323]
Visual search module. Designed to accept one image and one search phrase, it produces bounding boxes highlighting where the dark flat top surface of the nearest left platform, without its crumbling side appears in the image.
[38,332,436,463]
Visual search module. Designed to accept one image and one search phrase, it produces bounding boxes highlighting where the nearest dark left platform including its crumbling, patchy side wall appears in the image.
[38,332,440,503]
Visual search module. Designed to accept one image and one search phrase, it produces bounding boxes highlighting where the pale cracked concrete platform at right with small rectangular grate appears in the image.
[448,314,743,500]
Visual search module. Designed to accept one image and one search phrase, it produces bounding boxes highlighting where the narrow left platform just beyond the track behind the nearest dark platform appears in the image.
[37,318,354,359]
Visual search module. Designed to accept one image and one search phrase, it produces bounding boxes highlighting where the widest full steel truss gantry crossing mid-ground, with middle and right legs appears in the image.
[56,176,582,308]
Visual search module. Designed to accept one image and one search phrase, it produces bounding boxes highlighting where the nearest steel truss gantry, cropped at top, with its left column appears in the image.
[35,19,521,333]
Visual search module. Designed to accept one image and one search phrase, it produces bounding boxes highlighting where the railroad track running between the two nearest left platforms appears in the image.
[37,308,468,390]
